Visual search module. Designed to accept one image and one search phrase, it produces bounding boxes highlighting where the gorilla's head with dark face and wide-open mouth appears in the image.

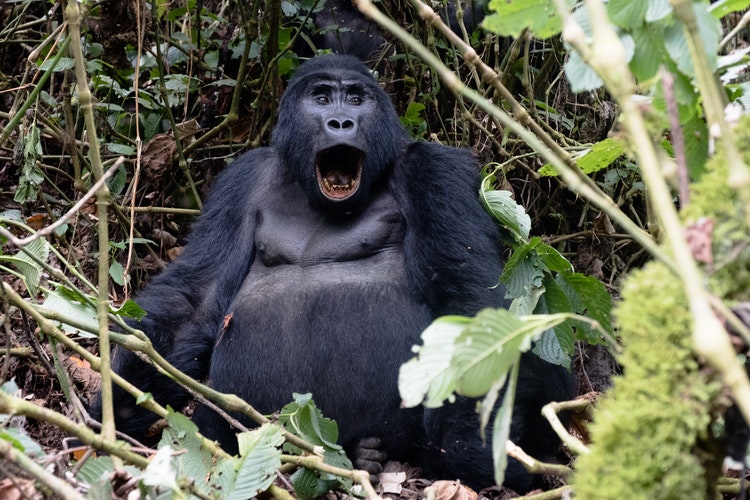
[272,55,409,213]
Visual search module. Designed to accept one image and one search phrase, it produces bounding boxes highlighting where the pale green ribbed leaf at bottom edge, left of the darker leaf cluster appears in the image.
[225,423,284,500]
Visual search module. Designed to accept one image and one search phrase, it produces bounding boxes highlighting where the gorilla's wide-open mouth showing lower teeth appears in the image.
[315,145,365,201]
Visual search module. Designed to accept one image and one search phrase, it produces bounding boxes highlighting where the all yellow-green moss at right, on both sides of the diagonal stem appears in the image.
[572,118,750,500]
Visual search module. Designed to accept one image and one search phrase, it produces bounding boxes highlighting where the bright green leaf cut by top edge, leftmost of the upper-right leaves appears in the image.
[482,0,575,40]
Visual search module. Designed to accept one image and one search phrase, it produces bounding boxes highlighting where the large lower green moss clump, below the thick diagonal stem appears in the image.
[573,263,719,500]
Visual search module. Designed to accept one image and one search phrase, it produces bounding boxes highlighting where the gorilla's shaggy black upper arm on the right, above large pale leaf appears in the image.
[391,142,504,314]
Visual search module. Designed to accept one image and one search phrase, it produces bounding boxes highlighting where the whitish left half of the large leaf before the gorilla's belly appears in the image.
[398,316,470,408]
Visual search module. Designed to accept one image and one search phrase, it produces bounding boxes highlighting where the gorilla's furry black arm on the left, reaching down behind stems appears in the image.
[97,149,274,438]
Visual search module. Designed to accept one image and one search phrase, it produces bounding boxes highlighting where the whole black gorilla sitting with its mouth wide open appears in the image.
[97,55,571,489]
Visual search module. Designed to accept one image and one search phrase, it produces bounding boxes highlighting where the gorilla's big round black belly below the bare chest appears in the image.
[211,248,431,445]
